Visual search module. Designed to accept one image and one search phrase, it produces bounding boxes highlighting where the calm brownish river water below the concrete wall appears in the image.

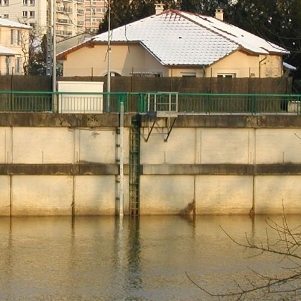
[0,216,300,300]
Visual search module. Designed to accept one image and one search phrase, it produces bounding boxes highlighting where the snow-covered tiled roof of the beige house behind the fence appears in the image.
[58,9,288,66]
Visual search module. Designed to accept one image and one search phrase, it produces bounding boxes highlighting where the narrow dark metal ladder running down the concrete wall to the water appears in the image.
[129,115,140,216]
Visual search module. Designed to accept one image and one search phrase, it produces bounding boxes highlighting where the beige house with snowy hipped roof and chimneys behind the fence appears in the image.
[57,9,289,78]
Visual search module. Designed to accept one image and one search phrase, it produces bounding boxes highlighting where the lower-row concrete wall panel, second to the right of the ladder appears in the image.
[195,175,253,214]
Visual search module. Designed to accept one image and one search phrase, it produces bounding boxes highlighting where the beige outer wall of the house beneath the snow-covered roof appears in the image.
[63,44,282,78]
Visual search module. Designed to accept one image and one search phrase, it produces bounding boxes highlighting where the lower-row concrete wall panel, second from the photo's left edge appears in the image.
[11,175,73,216]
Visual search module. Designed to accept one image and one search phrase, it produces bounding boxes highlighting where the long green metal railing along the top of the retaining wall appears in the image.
[0,91,301,115]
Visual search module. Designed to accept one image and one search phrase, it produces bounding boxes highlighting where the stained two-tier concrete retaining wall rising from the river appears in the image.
[0,113,301,216]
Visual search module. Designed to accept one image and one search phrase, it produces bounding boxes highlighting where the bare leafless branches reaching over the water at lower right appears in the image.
[186,205,301,300]
